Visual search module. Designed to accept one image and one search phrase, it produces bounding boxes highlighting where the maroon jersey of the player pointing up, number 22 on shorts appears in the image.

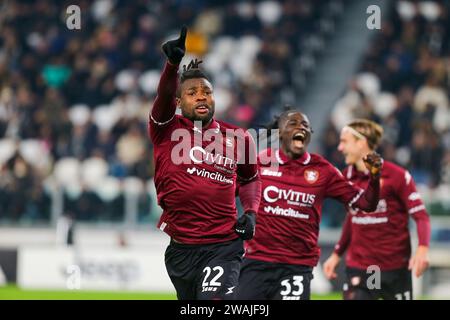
[149,64,260,244]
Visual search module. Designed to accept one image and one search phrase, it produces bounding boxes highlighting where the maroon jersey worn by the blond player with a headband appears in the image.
[335,161,430,271]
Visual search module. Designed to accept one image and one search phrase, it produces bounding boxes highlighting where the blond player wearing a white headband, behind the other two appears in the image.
[323,119,431,300]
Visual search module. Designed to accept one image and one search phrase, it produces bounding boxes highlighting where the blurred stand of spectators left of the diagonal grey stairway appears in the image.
[0,0,344,224]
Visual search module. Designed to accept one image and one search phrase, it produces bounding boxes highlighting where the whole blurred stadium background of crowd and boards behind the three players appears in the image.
[0,0,450,299]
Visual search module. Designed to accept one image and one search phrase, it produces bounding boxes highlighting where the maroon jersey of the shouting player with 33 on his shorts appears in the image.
[245,150,379,266]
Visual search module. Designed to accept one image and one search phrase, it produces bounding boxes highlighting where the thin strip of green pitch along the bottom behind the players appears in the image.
[0,285,341,300]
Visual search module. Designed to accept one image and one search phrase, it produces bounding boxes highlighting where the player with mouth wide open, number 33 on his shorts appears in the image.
[237,109,382,300]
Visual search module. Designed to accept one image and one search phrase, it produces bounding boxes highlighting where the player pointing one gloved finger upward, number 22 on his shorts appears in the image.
[149,27,261,299]
